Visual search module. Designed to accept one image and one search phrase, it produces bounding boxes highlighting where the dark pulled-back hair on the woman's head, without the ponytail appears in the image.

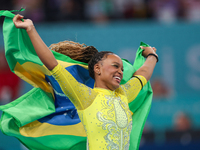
[88,51,114,79]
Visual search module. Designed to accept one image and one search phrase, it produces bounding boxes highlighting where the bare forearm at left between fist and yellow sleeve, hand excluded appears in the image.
[26,25,58,70]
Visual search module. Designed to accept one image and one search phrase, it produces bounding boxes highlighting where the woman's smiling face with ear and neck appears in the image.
[94,54,123,91]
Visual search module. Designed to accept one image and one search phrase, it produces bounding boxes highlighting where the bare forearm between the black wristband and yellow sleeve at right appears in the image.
[133,55,157,81]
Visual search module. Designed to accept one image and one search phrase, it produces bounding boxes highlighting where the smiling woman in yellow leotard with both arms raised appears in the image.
[13,15,158,150]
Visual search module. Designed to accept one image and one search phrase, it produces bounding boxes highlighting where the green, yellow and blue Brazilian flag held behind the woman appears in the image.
[0,9,153,150]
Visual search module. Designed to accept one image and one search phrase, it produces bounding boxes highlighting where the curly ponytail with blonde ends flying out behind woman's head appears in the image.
[49,41,98,63]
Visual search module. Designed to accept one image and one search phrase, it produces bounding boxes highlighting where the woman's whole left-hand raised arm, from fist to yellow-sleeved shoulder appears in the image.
[13,15,96,110]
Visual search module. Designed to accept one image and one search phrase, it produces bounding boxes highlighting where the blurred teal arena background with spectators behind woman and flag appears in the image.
[0,0,200,150]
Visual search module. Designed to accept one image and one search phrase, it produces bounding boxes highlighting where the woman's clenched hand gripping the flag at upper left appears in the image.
[13,14,34,31]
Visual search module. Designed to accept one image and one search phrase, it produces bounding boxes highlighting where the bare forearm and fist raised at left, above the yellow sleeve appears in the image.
[13,14,58,70]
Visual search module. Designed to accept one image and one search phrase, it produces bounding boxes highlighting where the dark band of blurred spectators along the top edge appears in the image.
[0,0,200,23]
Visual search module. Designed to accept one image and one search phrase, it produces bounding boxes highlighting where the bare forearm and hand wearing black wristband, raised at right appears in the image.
[133,46,158,81]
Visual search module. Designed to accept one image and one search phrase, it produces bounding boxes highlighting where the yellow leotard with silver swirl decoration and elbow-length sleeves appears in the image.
[51,64,147,150]
